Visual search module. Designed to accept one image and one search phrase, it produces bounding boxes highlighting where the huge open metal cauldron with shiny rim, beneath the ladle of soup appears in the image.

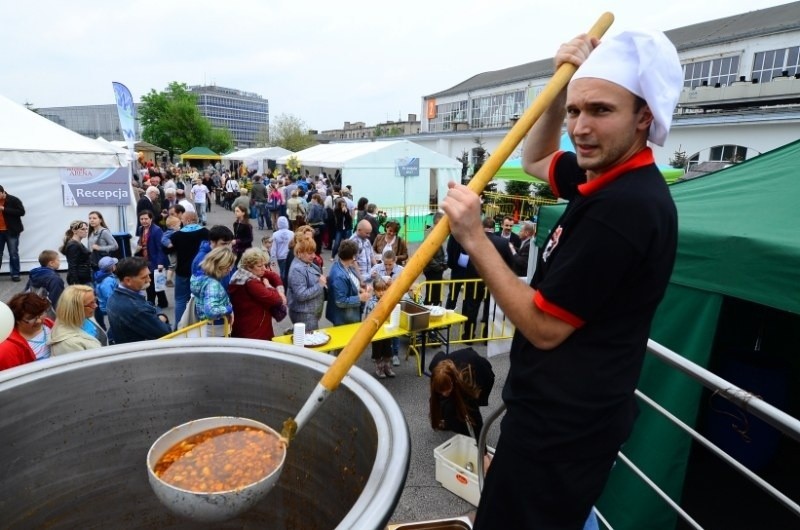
[0,339,410,530]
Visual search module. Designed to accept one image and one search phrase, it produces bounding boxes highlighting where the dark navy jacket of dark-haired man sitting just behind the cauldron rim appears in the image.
[107,284,172,344]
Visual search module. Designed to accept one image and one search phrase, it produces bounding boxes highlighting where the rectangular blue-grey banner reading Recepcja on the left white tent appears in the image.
[59,166,131,206]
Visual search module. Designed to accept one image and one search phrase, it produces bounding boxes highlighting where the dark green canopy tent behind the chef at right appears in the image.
[537,141,800,530]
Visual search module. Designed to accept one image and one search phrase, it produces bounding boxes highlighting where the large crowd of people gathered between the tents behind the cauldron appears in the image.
[0,164,536,378]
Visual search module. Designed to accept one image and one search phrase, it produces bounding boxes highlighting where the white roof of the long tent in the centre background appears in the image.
[277,140,461,169]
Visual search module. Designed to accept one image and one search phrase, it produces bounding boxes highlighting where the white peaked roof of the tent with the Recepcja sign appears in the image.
[0,96,124,168]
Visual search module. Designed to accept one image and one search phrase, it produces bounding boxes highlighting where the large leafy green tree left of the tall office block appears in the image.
[138,81,233,156]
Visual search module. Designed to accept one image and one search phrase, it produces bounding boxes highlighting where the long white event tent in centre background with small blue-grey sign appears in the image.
[278,140,461,207]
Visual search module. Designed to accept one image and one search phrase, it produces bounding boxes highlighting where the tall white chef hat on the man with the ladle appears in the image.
[572,30,683,146]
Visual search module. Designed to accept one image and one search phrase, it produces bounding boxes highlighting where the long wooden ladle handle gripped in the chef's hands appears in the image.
[295,12,614,438]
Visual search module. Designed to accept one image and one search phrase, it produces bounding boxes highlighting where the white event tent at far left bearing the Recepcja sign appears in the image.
[0,95,136,272]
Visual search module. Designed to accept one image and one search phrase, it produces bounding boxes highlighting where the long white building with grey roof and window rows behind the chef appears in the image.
[360,2,800,175]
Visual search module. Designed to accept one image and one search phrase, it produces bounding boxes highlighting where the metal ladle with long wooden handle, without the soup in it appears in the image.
[148,12,614,521]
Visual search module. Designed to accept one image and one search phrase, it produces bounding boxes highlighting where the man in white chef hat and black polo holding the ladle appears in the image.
[442,31,683,530]
